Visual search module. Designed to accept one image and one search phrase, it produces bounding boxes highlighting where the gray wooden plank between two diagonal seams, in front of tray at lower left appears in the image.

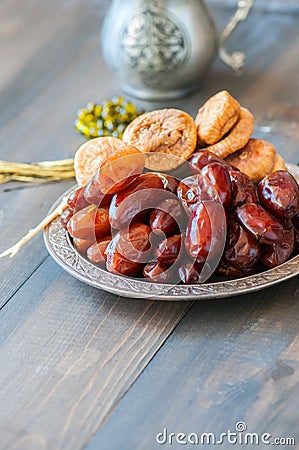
[0,258,190,450]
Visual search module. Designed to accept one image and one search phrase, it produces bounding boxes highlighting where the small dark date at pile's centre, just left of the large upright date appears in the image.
[150,198,186,236]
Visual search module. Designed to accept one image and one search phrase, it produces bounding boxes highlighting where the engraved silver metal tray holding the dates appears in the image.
[44,164,299,301]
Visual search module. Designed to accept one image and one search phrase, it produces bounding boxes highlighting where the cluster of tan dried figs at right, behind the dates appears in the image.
[195,91,286,183]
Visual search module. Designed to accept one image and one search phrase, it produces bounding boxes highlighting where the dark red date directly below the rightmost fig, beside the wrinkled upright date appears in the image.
[229,170,258,209]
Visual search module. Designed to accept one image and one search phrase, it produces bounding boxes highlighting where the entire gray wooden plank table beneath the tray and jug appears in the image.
[0,0,299,450]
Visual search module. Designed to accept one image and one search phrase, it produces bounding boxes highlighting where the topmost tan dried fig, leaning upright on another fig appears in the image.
[195,91,240,145]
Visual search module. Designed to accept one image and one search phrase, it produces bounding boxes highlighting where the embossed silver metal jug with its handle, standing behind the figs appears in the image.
[102,0,253,100]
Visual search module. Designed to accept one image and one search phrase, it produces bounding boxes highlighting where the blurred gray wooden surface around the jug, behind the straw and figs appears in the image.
[0,0,299,163]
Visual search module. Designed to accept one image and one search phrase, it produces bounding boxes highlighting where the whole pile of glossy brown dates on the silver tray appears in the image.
[61,145,299,284]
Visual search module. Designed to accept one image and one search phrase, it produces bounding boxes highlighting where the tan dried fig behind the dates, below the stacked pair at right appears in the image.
[226,138,276,183]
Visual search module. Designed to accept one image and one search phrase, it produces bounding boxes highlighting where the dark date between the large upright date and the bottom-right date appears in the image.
[221,220,261,269]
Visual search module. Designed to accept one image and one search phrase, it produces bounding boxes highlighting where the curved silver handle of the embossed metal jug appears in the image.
[218,0,254,73]
